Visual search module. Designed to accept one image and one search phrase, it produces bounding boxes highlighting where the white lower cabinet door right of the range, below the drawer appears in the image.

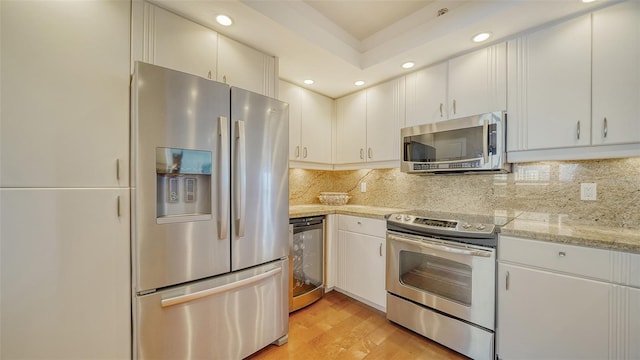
[497,263,612,360]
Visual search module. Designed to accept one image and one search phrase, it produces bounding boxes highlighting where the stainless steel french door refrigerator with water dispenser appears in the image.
[131,62,289,359]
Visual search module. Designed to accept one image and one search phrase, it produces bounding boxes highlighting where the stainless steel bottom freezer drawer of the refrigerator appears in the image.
[134,259,289,360]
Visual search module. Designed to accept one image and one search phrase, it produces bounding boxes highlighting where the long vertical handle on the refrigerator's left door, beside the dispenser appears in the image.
[218,116,229,240]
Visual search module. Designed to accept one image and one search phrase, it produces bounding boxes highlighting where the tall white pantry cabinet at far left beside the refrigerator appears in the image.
[0,1,131,359]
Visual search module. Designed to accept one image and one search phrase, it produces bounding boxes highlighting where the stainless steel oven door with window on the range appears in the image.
[386,231,496,330]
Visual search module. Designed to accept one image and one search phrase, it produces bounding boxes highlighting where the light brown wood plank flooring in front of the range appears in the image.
[247,291,467,360]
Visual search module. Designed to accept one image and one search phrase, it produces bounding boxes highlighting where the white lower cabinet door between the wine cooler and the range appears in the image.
[338,230,386,309]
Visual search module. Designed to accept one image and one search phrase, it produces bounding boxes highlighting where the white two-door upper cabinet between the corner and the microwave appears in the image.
[336,78,405,169]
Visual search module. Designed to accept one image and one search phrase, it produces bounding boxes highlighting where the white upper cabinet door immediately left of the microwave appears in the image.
[365,78,404,162]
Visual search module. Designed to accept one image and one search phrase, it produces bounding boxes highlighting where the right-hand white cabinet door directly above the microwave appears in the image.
[448,43,507,118]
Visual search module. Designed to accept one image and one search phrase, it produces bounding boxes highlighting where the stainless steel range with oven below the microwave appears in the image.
[386,210,510,359]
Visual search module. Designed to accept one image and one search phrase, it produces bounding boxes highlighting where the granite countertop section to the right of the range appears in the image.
[501,212,640,253]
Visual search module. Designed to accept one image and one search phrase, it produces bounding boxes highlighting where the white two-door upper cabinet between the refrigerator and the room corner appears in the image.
[279,80,333,169]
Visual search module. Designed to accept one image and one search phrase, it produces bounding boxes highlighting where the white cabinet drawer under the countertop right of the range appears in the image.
[498,236,612,280]
